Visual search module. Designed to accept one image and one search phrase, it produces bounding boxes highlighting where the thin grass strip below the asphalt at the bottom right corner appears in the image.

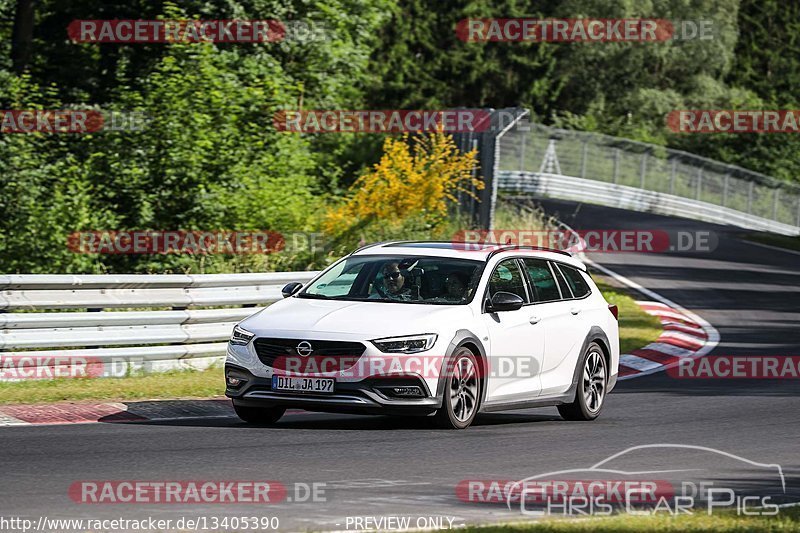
[464,507,800,533]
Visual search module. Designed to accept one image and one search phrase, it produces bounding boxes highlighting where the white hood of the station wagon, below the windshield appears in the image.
[240,298,472,339]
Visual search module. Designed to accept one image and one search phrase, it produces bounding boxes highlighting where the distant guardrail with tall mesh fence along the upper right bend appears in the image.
[496,122,800,235]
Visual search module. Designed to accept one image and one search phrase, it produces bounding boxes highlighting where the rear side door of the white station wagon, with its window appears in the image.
[523,258,588,397]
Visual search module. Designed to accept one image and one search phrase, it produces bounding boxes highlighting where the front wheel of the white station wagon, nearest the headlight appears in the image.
[434,346,481,429]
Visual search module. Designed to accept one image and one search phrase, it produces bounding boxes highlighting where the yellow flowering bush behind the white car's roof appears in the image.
[322,133,483,238]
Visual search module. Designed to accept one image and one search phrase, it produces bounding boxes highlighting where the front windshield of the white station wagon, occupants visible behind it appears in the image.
[298,255,484,305]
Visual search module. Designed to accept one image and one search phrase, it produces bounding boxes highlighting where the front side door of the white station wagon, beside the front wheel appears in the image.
[482,259,544,403]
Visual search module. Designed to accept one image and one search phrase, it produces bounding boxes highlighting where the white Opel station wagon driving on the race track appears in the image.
[225,242,619,429]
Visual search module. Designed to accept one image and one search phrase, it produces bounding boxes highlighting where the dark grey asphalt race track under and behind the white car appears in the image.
[0,202,800,530]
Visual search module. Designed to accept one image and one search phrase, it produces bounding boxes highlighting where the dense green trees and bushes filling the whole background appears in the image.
[0,0,800,272]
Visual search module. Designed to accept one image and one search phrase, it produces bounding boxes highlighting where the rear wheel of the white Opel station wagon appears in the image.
[558,342,608,420]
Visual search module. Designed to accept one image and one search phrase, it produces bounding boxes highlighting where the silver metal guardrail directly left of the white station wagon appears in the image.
[0,272,317,379]
